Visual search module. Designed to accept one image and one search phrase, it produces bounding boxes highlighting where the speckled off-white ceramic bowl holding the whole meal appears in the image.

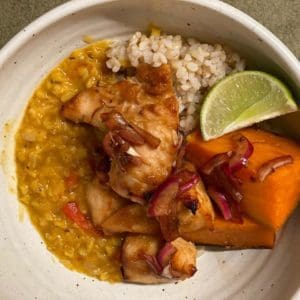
[0,0,300,300]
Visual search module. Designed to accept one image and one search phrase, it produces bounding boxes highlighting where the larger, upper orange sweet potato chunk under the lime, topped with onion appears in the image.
[187,128,300,230]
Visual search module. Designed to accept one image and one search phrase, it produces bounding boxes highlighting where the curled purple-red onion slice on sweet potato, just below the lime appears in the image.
[229,134,254,173]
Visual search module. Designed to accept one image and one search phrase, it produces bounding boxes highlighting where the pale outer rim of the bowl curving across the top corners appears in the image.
[0,0,300,85]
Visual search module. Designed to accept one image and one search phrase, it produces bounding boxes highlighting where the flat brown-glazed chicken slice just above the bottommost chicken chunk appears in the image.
[101,204,160,234]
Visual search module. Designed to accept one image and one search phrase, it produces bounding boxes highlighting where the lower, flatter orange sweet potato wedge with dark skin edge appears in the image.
[181,217,275,249]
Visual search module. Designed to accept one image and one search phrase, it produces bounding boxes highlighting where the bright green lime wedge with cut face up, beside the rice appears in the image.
[200,71,298,140]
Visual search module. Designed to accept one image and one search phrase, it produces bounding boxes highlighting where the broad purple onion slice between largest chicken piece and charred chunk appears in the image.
[147,177,179,217]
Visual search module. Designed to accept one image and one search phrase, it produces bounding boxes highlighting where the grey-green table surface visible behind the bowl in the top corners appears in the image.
[0,0,300,58]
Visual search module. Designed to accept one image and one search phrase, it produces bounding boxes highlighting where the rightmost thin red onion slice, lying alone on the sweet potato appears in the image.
[256,155,294,182]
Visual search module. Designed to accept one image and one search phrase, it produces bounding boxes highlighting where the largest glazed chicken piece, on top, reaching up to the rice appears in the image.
[62,64,179,201]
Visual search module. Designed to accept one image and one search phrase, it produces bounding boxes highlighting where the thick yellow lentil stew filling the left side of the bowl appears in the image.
[16,41,122,282]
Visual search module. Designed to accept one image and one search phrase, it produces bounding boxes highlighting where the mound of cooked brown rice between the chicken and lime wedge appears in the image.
[106,30,245,132]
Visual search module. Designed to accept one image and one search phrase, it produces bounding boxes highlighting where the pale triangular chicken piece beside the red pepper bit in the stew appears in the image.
[86,180,128,228]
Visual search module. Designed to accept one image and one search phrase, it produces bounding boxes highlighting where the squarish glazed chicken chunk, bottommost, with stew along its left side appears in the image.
[121,235,170,284]
